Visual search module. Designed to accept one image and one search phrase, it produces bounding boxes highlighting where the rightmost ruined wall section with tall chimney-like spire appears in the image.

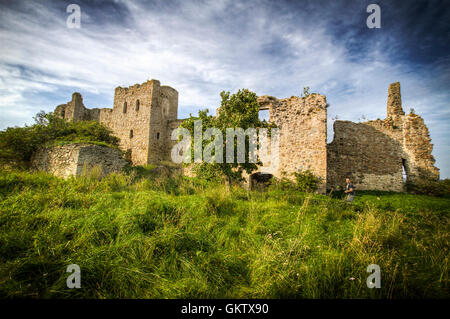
[327,82,439,192]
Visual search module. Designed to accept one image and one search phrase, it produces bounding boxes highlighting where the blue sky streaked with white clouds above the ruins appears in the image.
[0,0,450,178]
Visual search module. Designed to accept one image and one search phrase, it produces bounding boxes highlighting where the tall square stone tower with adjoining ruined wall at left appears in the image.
[55,80,178,165]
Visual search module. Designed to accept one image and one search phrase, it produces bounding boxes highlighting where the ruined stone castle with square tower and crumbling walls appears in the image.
[51,80,439,192]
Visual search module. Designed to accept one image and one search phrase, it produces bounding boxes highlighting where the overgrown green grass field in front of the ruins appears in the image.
[0,169,450,298]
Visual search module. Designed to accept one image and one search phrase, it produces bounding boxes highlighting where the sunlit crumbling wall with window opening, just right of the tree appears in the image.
[258,94,327,192]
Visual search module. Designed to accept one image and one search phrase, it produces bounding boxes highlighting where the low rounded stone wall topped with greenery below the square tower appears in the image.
[31,143,127,178]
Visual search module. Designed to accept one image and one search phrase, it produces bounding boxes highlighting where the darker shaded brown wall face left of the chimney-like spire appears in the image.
[327,121,403,192]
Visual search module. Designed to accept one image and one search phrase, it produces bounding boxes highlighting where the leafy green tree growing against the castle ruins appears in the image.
[181,89,275,186]
